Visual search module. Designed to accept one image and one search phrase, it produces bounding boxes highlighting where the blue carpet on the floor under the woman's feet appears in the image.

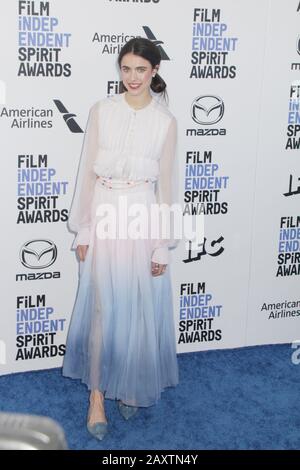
[0,345,300,450]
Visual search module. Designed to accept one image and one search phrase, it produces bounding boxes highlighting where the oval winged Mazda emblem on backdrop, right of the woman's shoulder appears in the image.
[192,95,224,126]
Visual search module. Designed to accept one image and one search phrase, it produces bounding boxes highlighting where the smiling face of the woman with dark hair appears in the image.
[120,52,156,96]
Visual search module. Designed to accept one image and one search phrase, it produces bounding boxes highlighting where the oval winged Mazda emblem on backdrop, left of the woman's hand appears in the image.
[20,239,57,269]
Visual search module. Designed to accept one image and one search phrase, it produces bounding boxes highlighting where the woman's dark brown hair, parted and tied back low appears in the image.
[118,38,168,99]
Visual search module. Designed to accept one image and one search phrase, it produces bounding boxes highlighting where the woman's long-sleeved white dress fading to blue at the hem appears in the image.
[63,93,179,407]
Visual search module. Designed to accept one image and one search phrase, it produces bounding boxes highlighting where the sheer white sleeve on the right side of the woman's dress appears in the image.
[151,116,179,264]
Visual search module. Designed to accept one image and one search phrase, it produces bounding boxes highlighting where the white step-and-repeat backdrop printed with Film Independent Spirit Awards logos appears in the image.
[0,0,300,374]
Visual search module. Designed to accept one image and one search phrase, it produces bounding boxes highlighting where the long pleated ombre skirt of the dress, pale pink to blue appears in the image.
[63,179,179,407]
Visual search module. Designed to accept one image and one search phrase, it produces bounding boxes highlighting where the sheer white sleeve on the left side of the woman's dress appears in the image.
[68,102,99,249]
